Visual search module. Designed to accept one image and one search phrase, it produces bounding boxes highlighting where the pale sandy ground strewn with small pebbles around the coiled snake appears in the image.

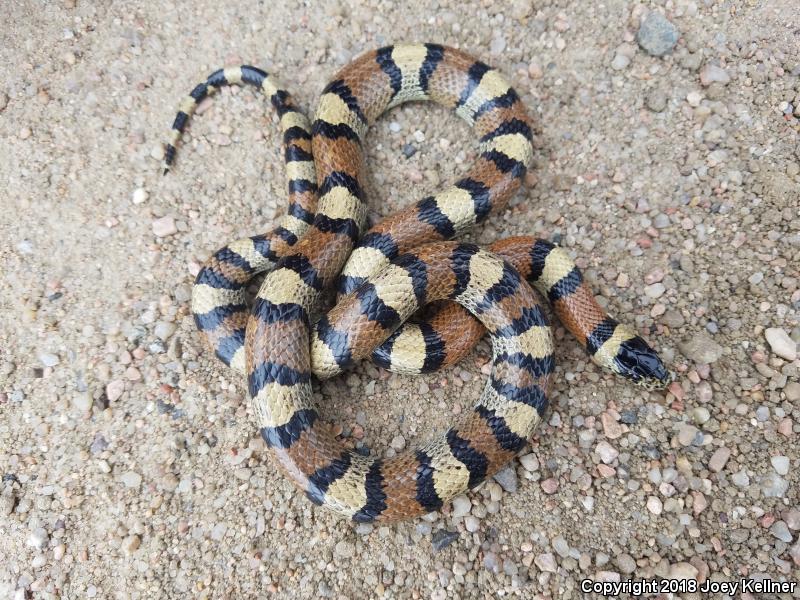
[0,0,800,599]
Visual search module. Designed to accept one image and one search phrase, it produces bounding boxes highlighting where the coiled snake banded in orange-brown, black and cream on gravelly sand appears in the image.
[164,43,674,522]
